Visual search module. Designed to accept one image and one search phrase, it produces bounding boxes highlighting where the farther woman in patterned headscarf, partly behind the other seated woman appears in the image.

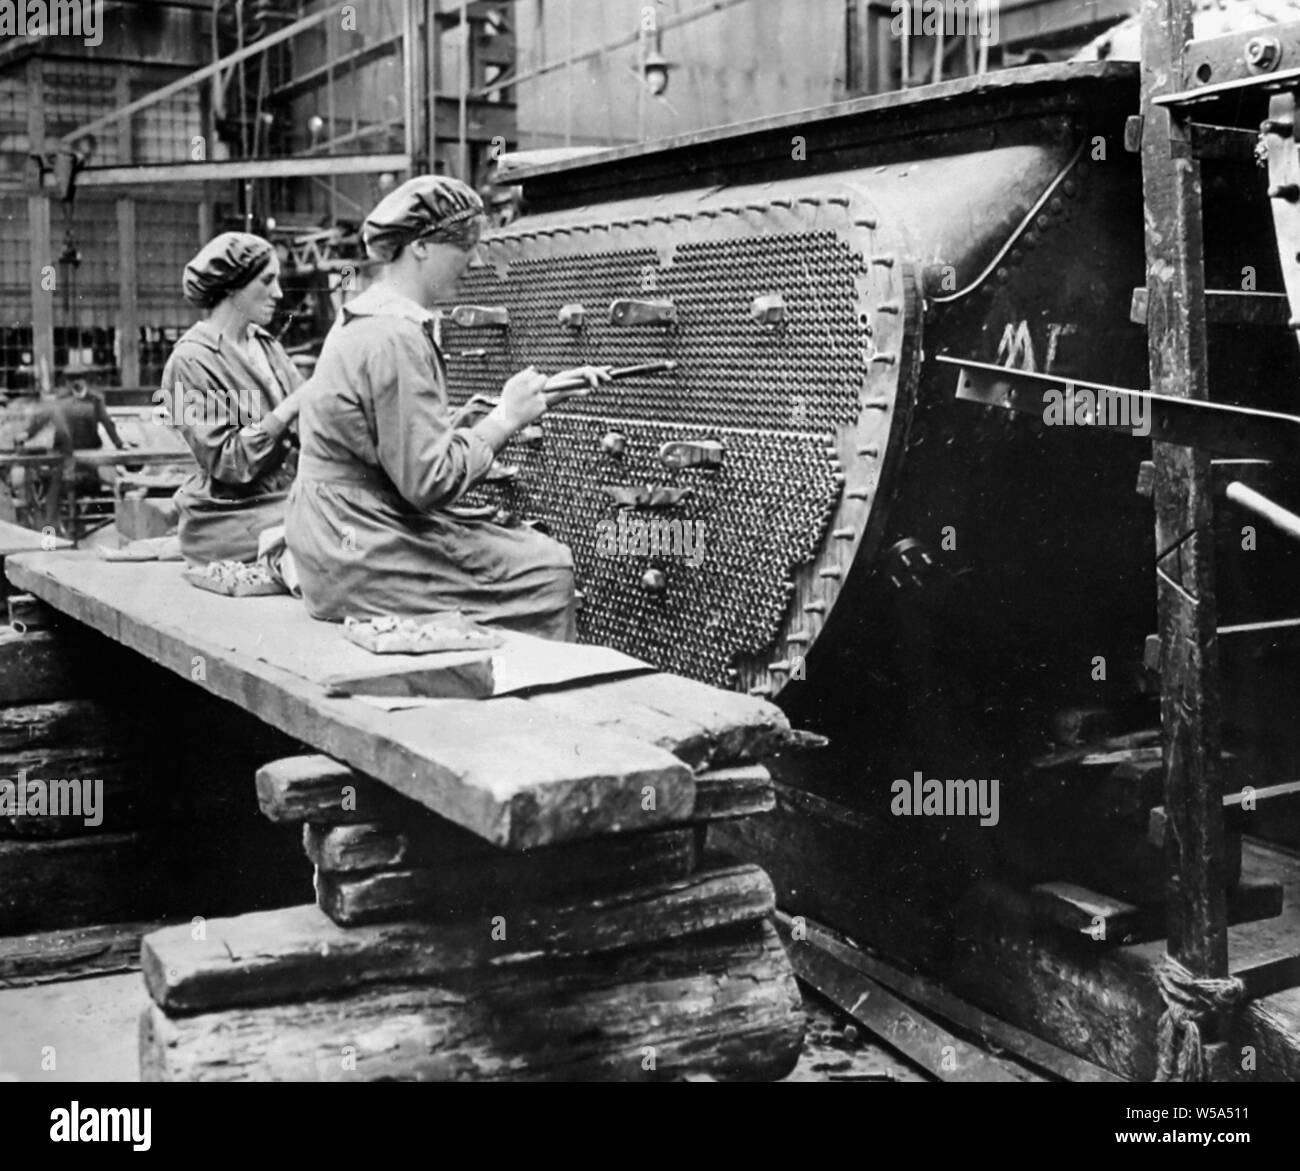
[163,231,302,571]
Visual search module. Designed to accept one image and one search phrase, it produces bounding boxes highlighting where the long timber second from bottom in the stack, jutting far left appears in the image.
[144,866,775,1016]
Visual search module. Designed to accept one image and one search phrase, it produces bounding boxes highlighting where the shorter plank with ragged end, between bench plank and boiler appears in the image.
[528,675,789,769]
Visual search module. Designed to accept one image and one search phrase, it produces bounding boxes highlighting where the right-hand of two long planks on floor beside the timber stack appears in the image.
[777,912,1123,1081]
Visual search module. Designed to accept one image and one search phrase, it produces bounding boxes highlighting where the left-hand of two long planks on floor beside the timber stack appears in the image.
[783,920,1043,1081]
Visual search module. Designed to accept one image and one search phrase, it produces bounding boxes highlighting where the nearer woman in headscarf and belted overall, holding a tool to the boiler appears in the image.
[286,175,597,639]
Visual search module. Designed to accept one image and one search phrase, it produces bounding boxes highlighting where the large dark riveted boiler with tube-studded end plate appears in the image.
[443,62,1297,760]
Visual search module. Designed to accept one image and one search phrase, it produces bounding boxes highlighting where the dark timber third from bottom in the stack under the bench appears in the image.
[316,829,696,925]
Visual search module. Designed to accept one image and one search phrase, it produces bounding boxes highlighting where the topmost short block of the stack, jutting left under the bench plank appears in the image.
[256,755,410,825]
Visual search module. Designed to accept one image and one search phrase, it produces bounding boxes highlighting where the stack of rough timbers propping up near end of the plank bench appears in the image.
[142,676,803,1080]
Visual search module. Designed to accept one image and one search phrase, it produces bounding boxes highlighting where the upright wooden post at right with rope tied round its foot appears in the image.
[1141,0,1227,977]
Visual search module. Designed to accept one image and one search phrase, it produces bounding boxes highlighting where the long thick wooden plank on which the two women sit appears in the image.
[7,552,694,849]
